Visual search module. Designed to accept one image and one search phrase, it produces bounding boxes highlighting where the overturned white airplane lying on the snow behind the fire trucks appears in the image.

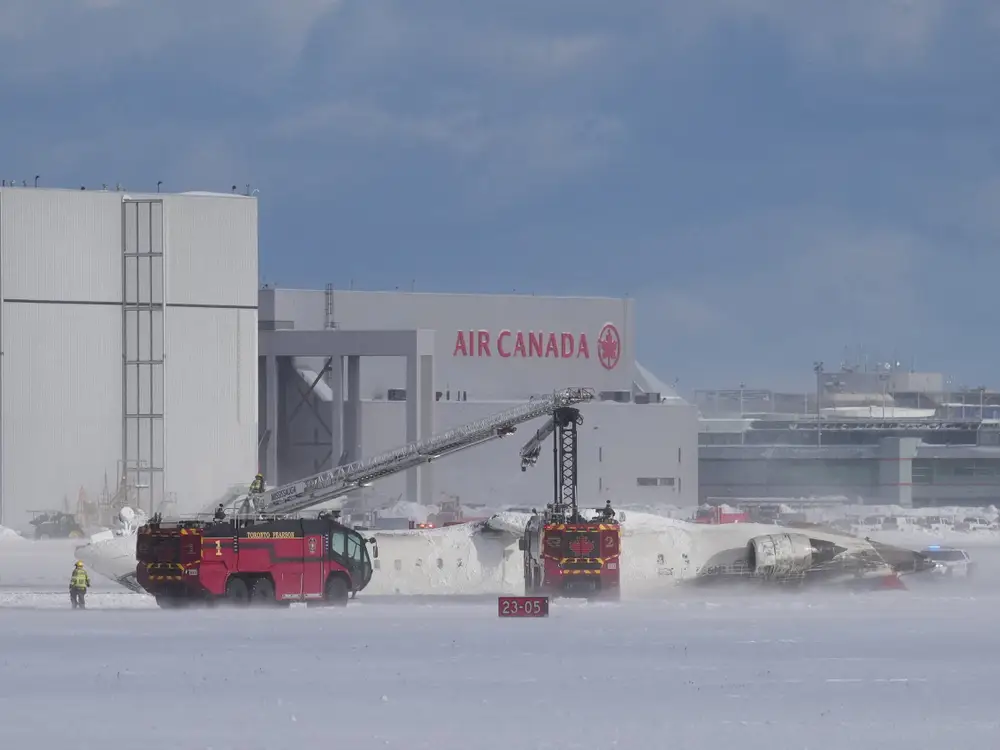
[77,502,935,598]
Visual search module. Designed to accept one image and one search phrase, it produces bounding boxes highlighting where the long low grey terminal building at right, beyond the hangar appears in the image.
[695,363,1000,507]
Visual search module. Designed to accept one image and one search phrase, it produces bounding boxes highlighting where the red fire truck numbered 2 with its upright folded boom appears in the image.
[518,406,621,600]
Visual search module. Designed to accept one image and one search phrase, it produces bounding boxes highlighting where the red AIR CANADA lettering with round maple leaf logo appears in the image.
[451,323,622,370]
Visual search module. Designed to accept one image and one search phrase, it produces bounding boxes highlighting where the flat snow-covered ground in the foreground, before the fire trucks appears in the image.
[0,589,1000,750]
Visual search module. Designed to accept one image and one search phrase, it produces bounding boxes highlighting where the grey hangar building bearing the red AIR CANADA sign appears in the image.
[259,285,698,507]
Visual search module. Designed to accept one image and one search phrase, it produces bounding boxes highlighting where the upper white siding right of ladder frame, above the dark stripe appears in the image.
[162,195,258,307]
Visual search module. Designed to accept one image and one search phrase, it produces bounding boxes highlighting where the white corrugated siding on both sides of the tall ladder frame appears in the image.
[0,189,257,524]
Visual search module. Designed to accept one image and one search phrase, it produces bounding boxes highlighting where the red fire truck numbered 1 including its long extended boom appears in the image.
[135,388,594,607]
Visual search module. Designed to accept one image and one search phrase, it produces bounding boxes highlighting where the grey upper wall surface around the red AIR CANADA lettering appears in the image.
[274,289,635,406]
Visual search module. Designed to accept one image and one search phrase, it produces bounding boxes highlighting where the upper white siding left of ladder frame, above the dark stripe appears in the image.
[0,188,122,302]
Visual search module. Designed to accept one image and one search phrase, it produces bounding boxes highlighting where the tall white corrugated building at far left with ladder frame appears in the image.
[0,187,258,528]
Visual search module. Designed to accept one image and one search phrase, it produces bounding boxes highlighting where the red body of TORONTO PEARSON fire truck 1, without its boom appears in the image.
[136,514,378,607]
